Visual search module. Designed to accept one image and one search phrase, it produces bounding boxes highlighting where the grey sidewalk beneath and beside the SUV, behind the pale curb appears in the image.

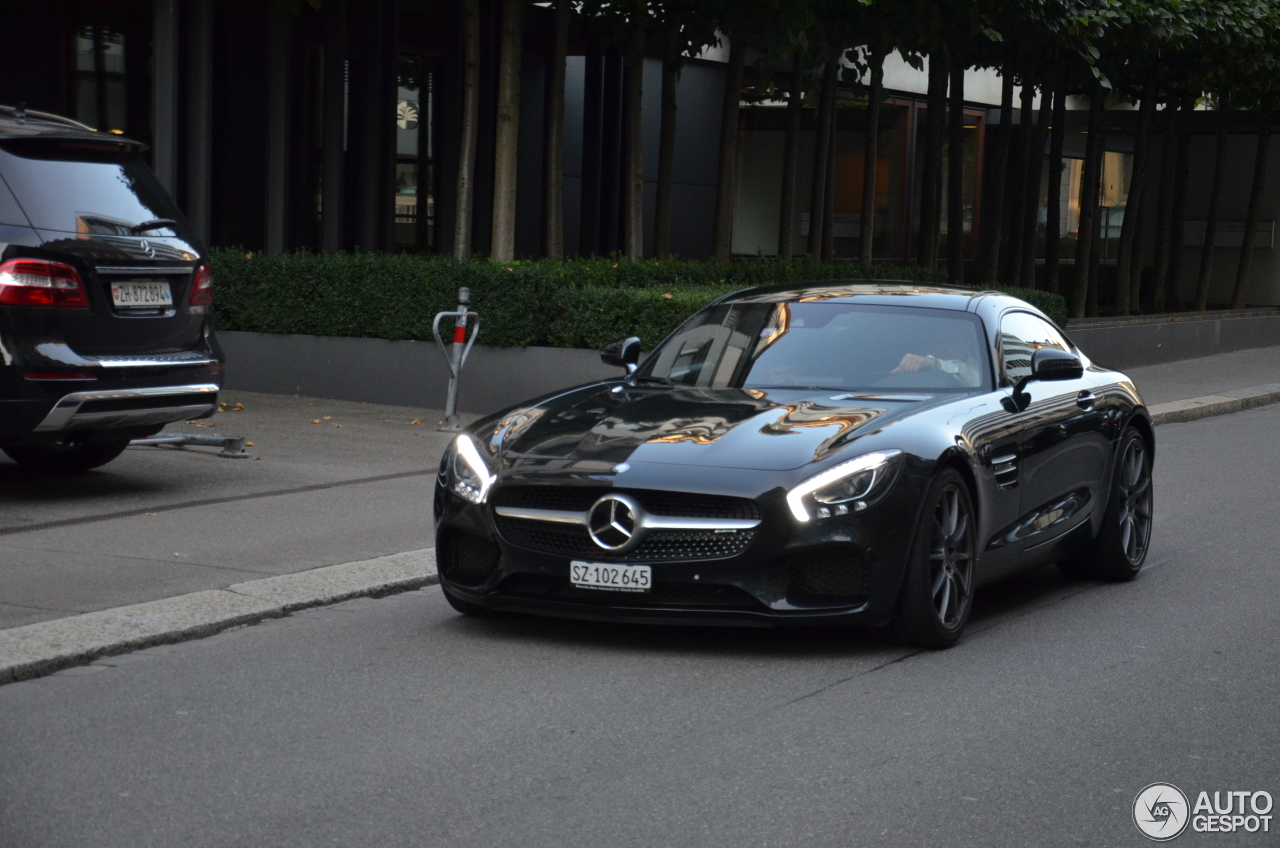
[0,392,470,629]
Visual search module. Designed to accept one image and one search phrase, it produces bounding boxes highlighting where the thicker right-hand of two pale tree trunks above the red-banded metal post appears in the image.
[490,0,525,263]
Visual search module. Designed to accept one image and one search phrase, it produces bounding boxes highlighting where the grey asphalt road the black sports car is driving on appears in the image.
[0,406,1280,848]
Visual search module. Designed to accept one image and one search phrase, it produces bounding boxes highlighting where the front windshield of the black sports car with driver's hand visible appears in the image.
[636,301,991,392]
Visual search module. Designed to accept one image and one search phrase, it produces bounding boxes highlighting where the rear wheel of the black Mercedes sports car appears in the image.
[1057,428,1155,583]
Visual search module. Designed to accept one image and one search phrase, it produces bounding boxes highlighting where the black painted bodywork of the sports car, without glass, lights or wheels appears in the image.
[435,282,1153,625]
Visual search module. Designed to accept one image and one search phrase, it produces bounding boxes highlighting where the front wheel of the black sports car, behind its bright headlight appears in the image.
[892,469,977,648]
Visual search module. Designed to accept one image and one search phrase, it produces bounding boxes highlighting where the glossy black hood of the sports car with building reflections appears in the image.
[483,384,934,473]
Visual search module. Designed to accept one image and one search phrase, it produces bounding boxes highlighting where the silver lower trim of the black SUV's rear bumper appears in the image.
[35,383,219,433]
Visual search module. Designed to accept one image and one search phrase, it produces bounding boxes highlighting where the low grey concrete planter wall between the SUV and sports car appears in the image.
[218,332,622,415]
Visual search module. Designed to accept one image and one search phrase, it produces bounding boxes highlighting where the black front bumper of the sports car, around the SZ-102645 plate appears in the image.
[435,475,920,626]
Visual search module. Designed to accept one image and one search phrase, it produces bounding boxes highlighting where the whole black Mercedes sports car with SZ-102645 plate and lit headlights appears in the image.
[435,282,1155,647]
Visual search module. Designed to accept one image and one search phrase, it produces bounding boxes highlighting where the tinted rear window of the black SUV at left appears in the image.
[0,138,182,236]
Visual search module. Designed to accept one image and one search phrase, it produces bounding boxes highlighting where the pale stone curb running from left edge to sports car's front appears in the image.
[0,548,438,685]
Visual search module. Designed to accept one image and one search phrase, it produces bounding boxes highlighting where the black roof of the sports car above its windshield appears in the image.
[721,279,1003,311]
